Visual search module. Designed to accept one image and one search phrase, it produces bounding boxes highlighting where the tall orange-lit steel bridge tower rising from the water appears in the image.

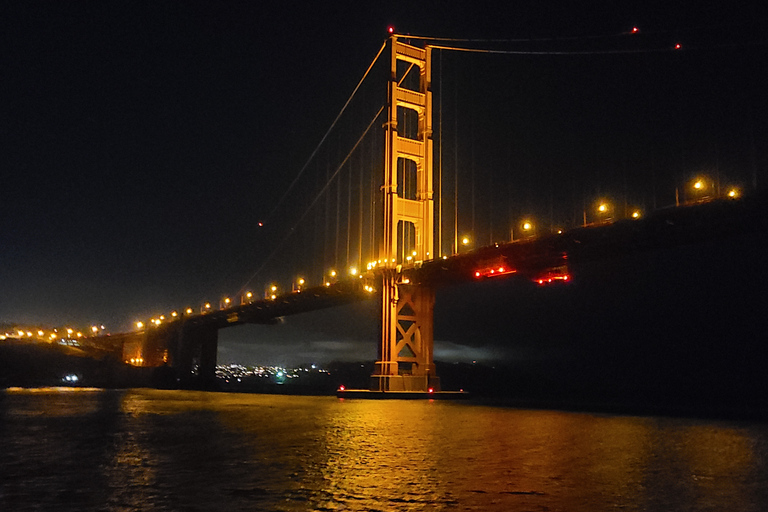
[371,36,440,391]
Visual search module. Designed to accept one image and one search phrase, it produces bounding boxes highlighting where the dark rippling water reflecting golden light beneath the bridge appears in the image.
[0,389,768,512]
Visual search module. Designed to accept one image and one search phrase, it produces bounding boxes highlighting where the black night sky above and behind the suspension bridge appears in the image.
[0,1,768,362]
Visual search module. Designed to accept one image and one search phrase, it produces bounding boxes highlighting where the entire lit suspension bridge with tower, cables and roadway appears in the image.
[82,35,765,392]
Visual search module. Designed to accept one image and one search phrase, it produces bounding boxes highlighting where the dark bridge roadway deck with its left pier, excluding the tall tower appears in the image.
[81,194,768,385]
